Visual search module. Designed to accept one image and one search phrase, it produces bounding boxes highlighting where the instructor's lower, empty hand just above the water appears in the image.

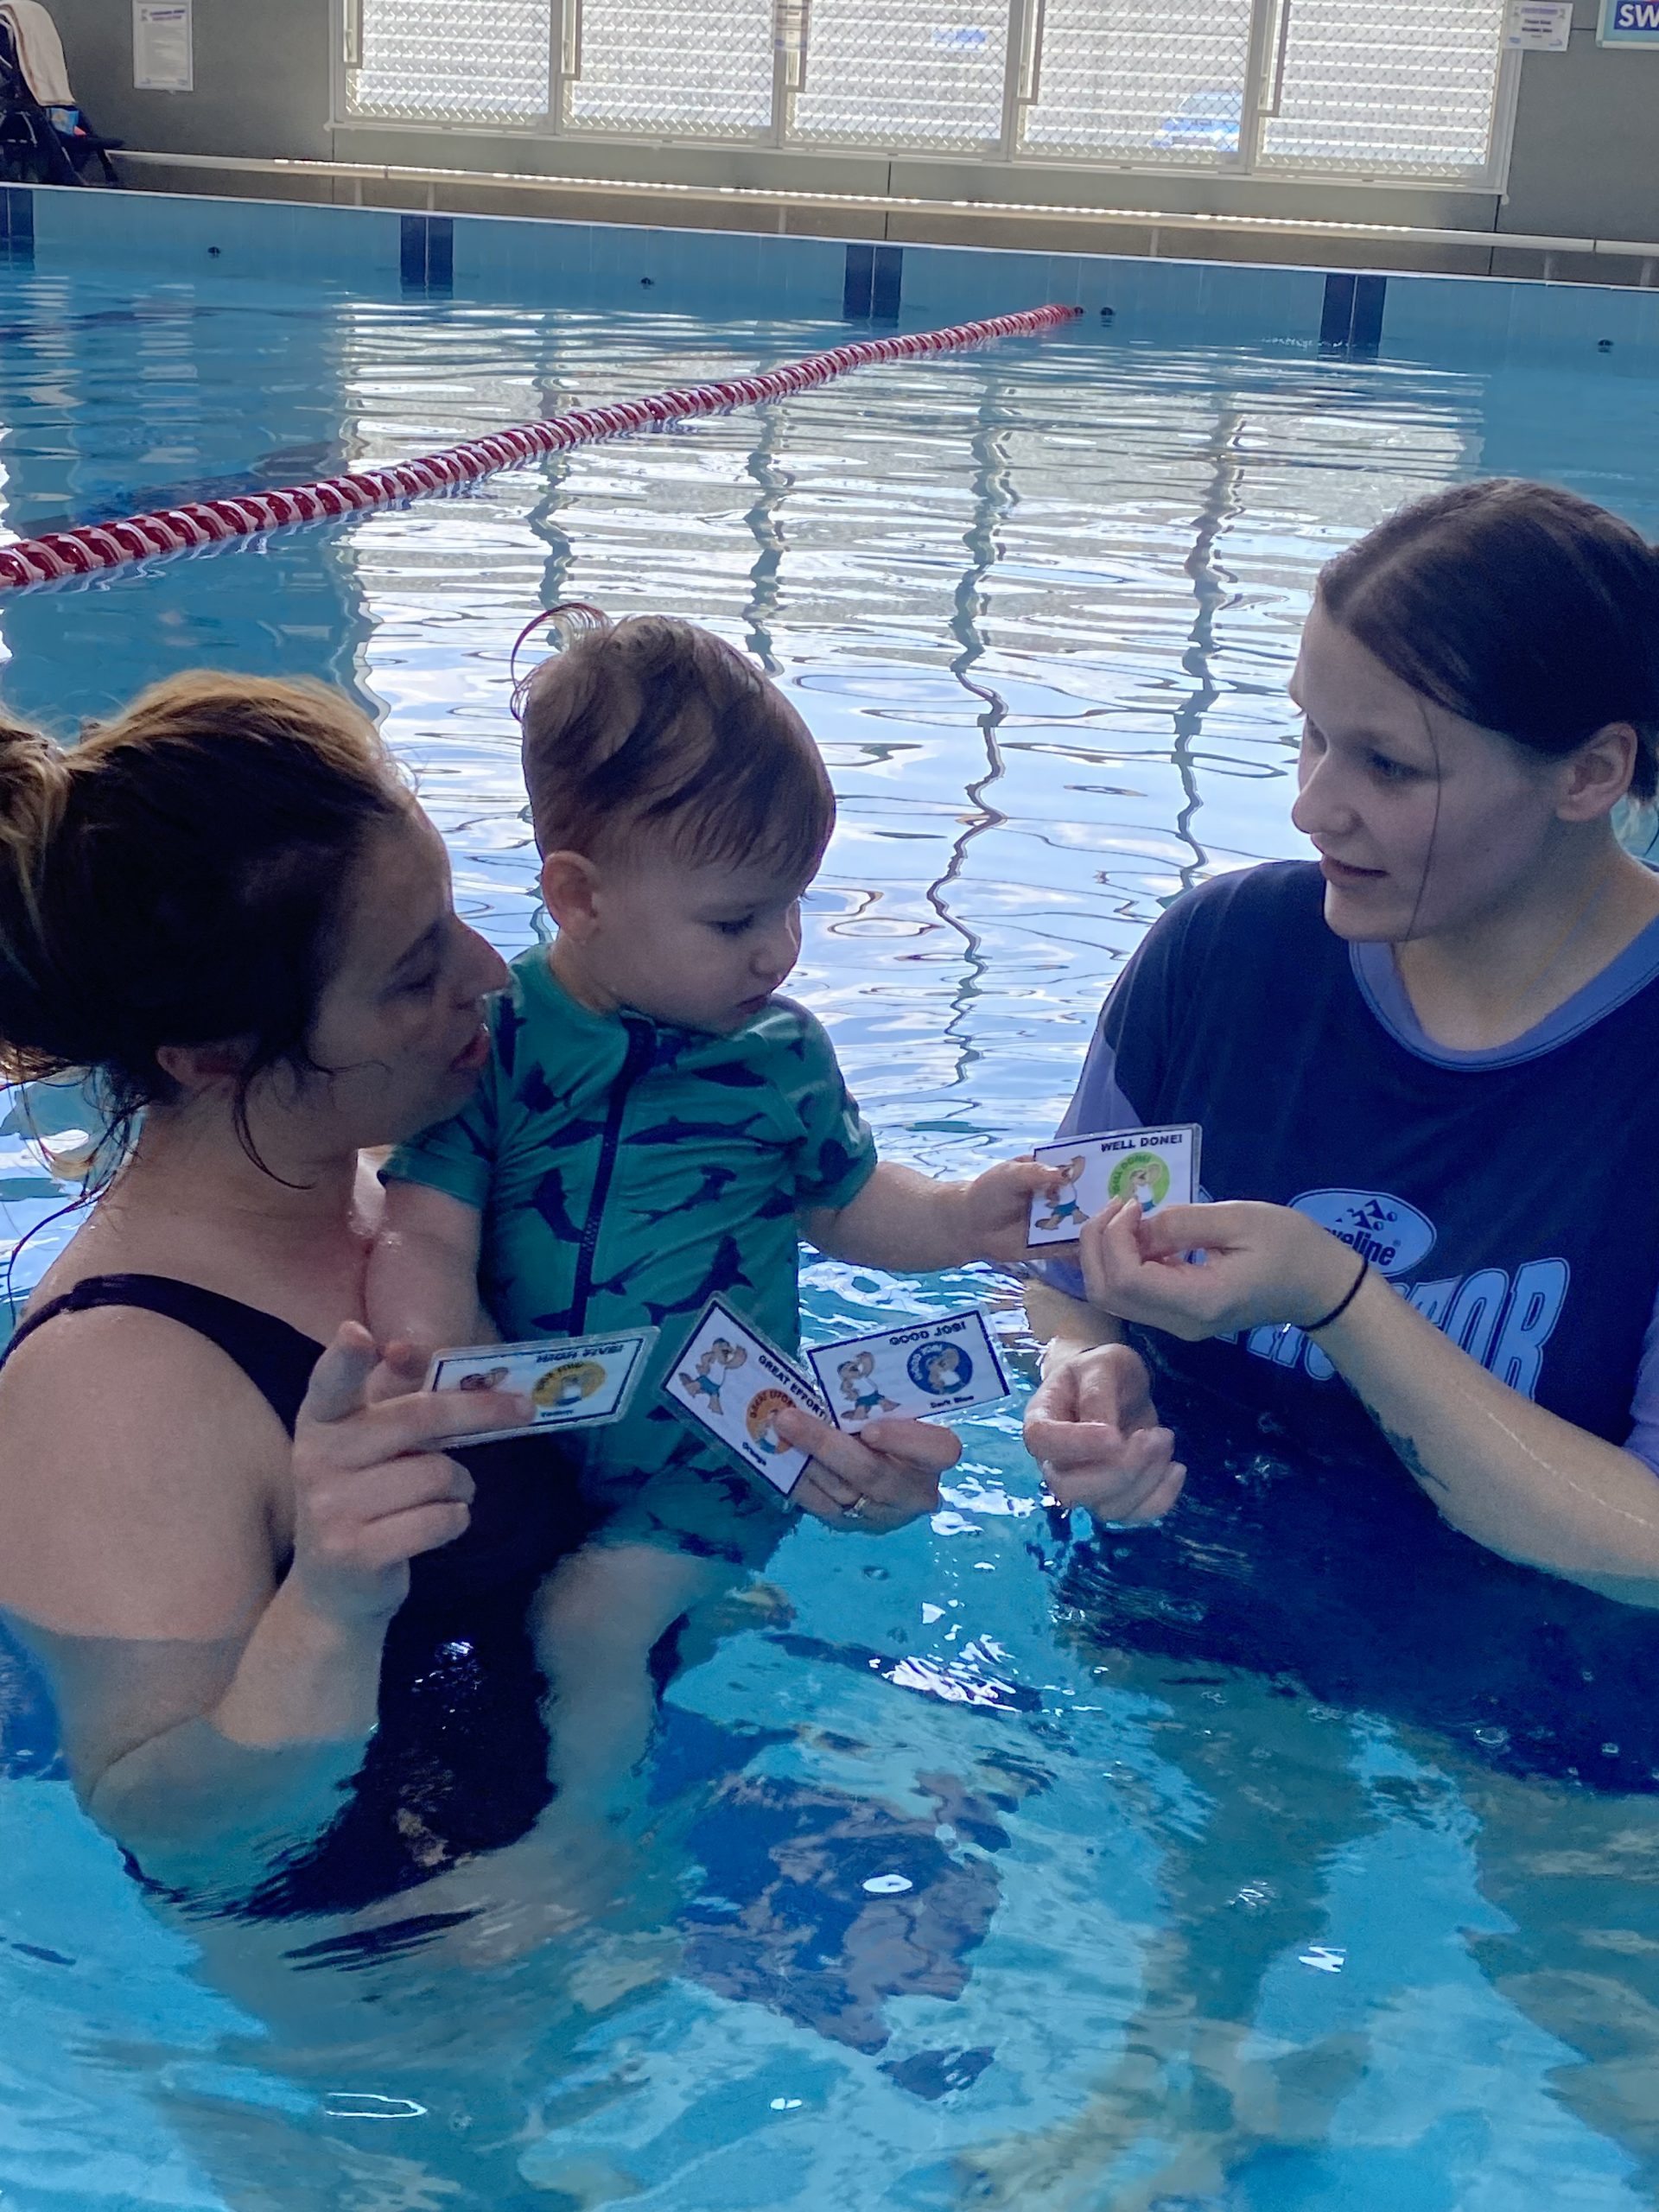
[1027,1344,1185,1522]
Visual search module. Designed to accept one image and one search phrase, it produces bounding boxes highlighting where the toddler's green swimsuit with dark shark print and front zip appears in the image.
[383,944,876,1566]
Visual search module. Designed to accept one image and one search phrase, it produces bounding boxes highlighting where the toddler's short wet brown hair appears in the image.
[522,608,836,878]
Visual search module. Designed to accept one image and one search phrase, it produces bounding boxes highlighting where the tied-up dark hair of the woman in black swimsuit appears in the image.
[0,675,410,1153]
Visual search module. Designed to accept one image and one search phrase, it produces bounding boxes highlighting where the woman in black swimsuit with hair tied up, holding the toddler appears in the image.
[0,677,956,1911]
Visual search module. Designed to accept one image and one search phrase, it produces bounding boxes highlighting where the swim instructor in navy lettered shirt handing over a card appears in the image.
[1027,482,1659,1606]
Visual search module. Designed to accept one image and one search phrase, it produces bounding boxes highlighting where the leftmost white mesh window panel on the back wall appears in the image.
[345,0,553,122]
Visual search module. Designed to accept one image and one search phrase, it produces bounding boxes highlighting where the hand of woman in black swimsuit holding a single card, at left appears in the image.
[288,1320,533,1621]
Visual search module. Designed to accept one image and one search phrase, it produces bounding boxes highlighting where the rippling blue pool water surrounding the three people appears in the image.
[0,272,1659,2212]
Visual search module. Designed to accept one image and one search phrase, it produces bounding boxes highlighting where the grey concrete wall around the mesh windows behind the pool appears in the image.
[29,0,1659,256]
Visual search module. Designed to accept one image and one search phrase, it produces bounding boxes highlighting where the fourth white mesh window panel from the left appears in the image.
[1020,0,1249,168]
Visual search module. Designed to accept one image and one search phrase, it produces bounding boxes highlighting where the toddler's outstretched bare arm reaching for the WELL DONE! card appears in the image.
[801,1159,1059,1274]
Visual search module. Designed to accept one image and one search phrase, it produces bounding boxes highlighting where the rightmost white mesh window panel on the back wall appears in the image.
[1261,0,1504,177]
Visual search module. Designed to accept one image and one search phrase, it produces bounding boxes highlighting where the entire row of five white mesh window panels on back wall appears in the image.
[340,0,1506,183]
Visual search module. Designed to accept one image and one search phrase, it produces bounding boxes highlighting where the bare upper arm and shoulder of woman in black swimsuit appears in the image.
[0,1307,289,1637]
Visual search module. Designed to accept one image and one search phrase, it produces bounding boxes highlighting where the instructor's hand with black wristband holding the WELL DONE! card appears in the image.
[1077,1201,1358,1343]
